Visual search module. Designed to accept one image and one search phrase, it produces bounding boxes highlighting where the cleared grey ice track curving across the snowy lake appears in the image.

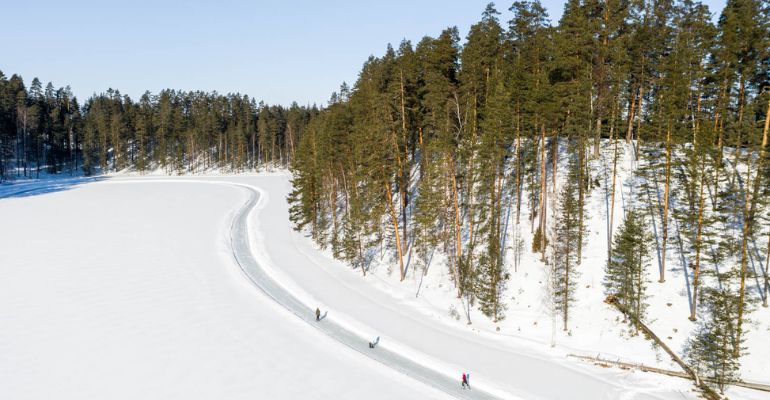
[230,184,496,399]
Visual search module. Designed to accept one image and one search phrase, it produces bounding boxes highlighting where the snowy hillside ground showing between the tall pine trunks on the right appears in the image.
[280,141,770,398]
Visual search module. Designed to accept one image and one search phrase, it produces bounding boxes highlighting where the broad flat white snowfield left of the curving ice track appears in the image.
[0,182,445,399]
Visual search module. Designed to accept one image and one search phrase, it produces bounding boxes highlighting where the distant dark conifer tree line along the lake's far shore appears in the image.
[0,72,318,181]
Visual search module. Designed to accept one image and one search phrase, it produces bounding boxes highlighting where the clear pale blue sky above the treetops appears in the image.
[0,0,725,105]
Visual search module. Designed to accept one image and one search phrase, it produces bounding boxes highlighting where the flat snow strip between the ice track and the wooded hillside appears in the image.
[220,176,689,399]
